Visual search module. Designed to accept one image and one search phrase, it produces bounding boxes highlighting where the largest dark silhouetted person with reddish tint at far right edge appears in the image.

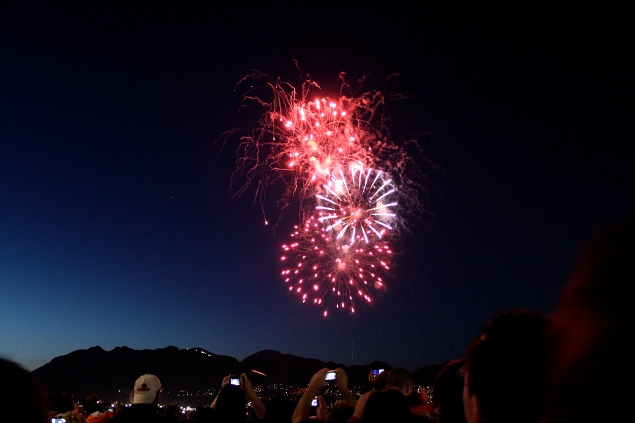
[541,215,635,423]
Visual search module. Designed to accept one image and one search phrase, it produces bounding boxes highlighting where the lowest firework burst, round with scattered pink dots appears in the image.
[281,216,392,316]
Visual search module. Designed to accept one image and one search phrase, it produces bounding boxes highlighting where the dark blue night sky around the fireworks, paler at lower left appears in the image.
[0,1,635,370]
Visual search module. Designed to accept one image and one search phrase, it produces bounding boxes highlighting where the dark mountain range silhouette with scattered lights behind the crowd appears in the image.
[33,346,442,406]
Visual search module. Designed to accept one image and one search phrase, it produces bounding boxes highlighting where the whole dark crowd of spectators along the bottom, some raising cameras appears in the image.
[0,218,635,423]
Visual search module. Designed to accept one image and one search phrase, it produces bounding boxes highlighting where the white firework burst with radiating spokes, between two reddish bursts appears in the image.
[316,164,397,245]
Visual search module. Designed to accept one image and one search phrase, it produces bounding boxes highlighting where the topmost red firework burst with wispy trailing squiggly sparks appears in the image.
[221,72,398,222]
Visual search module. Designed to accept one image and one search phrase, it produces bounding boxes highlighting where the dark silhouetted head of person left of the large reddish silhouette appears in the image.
[463,310,549,423]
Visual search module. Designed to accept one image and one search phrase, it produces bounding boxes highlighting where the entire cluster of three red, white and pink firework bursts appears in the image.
[221,68,427,315]
